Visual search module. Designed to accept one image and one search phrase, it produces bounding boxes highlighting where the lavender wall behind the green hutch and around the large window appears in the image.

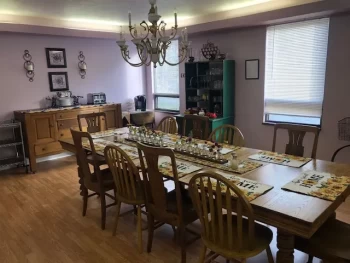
[150,15,350,162]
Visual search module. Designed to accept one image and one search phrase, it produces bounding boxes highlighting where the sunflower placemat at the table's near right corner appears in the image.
[282,170,350,201]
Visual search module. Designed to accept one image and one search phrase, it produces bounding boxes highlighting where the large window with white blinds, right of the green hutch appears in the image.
[264,18,329,125]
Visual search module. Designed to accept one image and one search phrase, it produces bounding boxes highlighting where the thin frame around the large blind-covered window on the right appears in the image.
[263,18,330,129]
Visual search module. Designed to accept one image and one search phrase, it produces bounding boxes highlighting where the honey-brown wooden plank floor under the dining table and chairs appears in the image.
[0,157,350,263]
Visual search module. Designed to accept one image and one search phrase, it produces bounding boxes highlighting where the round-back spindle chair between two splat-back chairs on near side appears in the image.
[105,146,145,253]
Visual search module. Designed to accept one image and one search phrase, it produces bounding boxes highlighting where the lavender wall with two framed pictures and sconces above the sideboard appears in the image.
[0,33,145,120]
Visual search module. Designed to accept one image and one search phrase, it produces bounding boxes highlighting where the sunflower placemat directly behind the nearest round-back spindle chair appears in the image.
[203,172,273,202]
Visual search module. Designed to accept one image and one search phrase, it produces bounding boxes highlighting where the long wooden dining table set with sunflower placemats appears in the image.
[60,130,350,263]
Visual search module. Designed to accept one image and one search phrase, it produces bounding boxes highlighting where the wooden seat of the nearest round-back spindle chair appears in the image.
[203,215,273,258]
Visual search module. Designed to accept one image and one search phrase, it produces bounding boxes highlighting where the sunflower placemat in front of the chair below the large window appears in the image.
[249,151,312,168]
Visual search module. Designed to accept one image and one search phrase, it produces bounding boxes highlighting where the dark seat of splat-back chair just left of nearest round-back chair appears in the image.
[167,190,198,224]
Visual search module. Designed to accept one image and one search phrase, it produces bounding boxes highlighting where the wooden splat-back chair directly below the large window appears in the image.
[272,124,320,159]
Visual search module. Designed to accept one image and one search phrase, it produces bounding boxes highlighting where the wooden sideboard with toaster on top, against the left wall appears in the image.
[14,104,123,173]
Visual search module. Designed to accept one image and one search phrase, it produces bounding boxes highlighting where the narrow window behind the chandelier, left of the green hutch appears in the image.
[152,40,180,112]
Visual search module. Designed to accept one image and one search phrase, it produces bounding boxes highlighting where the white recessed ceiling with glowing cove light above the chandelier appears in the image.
[0,0,322,32]
